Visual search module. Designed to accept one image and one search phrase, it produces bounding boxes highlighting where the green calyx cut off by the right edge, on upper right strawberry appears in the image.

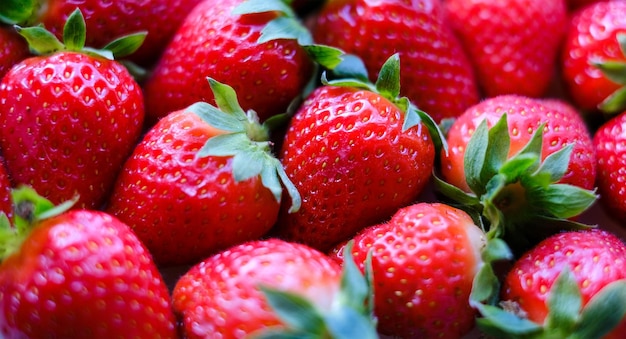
[591,33,626,115]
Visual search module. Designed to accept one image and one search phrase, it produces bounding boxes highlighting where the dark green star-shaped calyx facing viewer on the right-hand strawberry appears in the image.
[435,114,597,252]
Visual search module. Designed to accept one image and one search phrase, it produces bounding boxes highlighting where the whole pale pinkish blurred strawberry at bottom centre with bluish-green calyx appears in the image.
[172,239,377,339]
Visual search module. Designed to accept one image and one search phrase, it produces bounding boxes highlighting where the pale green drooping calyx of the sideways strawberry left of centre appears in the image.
[187,78,301,212]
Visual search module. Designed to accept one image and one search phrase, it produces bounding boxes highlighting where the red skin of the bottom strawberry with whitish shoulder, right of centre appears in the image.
[331,203,486,338]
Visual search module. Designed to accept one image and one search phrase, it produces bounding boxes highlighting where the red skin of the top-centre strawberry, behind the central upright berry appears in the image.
[312,0,479,122]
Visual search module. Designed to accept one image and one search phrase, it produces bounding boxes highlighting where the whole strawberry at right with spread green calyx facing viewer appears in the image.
[436,95,596,252]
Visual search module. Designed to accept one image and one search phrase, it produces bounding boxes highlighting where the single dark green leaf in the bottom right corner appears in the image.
[572,280,626,339]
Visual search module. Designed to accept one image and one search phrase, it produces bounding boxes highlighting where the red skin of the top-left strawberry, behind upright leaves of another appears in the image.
[37,0,201,66]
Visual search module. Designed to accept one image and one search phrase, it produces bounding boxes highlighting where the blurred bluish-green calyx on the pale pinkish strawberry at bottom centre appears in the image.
[247,242,378,339]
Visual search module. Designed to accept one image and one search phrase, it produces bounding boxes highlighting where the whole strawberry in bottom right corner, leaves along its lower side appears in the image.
[479,230,626,339]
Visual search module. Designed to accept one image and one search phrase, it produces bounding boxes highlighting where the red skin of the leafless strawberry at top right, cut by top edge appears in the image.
[445,0,568,97]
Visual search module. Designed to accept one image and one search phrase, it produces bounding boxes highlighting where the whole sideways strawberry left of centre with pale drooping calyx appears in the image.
[106,79,299,265]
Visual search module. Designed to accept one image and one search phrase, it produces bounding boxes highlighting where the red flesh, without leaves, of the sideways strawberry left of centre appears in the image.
[106,110,279,265]
